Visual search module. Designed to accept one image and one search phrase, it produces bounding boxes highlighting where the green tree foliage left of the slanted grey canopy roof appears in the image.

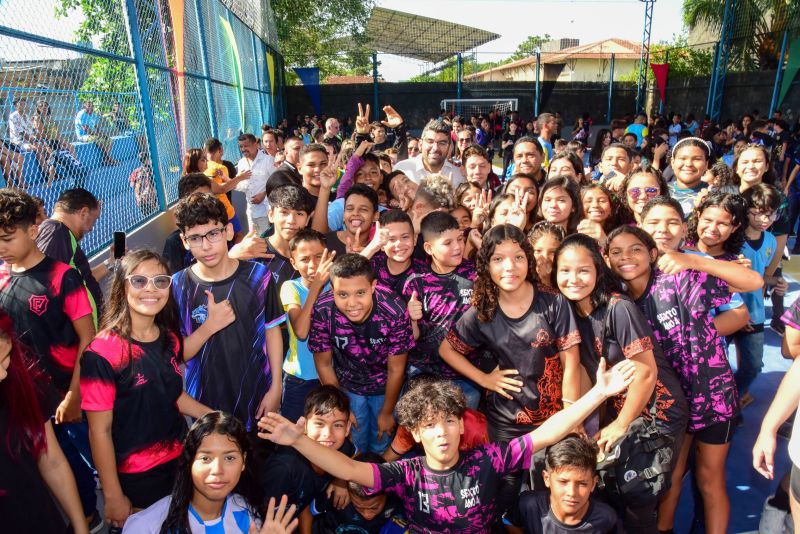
[271,0,376,83]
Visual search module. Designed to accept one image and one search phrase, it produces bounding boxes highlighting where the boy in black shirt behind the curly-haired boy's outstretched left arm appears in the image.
[260,386,355,531]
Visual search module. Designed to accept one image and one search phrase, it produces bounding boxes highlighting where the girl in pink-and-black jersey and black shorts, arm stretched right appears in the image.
[606,226,763,534]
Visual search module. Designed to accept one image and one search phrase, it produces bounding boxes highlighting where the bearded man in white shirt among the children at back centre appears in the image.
[394,119,465,189]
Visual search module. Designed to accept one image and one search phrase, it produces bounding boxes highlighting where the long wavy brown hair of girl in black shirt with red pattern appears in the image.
[472,224,538,323]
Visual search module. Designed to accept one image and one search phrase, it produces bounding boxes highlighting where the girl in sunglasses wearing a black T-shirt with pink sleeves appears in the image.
[81,250,210,528]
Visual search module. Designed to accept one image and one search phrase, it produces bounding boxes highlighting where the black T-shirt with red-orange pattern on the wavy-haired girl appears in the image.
[447,286,581,435]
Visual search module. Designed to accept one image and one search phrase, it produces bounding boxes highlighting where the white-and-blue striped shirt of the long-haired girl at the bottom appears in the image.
[122,493,260,534]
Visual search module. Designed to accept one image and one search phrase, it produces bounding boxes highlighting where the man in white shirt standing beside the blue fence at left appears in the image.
[236,134,275,235]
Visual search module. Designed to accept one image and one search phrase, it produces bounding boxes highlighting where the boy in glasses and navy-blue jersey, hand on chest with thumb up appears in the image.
[172,193,285,430]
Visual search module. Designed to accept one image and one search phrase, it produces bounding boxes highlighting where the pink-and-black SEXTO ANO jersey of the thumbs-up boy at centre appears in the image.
[403,260,477,379]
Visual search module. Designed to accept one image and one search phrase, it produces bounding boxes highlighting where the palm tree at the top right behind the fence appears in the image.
[683,0,800,70]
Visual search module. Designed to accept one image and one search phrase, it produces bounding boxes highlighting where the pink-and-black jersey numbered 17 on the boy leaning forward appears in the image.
[308,286,414,395]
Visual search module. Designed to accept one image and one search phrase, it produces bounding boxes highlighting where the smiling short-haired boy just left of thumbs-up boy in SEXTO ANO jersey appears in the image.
[360,209,427,295]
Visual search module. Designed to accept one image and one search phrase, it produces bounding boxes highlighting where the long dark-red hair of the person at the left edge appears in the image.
[0,310,47,460]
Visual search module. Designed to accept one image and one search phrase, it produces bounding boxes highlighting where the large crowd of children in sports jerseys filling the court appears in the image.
[0,105,800,534]
